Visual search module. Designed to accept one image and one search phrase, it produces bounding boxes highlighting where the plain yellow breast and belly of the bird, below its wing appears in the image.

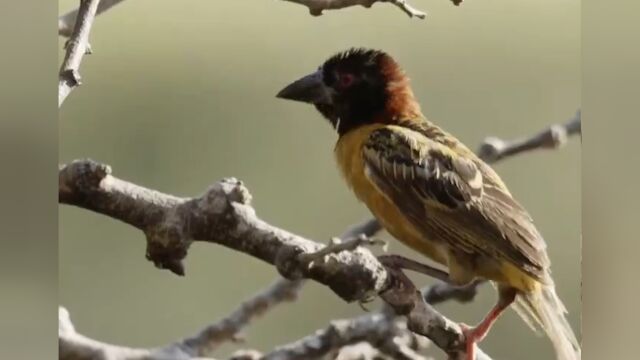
[335,124,446,264]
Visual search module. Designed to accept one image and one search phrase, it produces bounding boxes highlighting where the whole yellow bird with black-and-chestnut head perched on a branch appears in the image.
[277,49,581,360]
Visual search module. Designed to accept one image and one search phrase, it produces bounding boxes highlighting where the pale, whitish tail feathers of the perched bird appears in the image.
[512,283,582,360]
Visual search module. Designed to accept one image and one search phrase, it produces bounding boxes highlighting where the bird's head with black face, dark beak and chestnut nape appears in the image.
[277,49,421,134]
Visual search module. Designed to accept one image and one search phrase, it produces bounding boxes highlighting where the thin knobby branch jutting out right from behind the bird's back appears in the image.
[478,111,582,163]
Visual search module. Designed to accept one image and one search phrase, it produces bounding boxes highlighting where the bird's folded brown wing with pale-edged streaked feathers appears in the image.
[363,127,549,279]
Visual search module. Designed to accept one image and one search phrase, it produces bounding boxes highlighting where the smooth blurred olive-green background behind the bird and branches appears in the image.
[59,0,581,360]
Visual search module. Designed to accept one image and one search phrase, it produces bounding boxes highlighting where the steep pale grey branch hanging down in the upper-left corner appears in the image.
[58,0,100,107]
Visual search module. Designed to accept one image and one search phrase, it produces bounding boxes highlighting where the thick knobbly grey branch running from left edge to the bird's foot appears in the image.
[58,160,490,359]
